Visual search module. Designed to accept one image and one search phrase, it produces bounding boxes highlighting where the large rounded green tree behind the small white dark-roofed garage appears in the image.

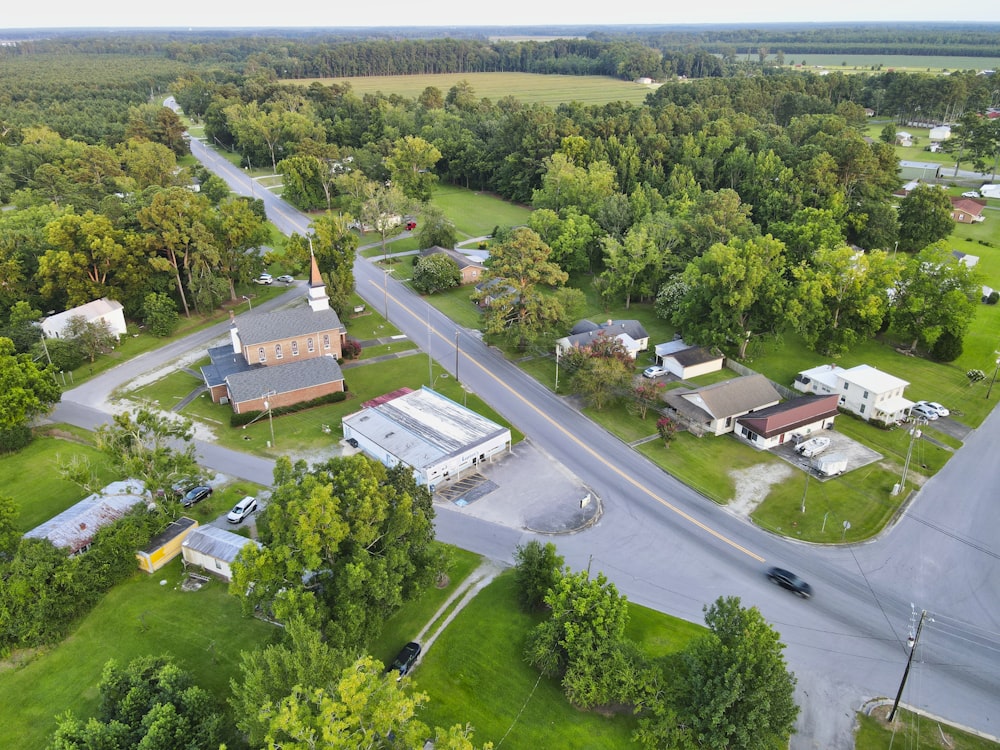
[671,235,787,359]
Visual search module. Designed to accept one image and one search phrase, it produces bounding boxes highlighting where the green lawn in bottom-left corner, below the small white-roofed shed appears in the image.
[0,558,280,748]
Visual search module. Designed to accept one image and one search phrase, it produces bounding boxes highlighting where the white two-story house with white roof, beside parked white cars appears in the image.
[792,365,913,422]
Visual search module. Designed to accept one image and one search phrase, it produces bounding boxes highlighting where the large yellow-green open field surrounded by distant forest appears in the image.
[289,73,656,107]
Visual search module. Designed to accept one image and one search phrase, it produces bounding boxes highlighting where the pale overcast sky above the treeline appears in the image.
[0,0,1000,29]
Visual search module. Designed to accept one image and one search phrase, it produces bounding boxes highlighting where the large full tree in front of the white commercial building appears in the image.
[230,455,441,650]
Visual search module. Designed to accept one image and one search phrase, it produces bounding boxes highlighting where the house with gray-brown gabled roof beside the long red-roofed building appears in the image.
[664,374,781,435]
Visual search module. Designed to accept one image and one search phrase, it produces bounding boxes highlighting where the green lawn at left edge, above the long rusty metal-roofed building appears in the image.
[0,425,122,536]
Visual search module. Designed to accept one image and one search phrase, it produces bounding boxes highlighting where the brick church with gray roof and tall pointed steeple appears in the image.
[201,256,347,413]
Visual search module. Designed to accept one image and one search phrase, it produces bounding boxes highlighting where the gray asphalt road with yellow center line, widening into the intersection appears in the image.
[74,117,1000,748]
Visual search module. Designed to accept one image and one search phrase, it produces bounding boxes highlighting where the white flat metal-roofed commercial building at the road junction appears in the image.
[343,387,511,491]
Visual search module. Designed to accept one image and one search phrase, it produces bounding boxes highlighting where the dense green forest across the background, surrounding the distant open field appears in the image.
[0,31,998,356]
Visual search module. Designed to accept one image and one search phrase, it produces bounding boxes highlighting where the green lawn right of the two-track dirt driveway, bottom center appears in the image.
[413,573,703,750]
